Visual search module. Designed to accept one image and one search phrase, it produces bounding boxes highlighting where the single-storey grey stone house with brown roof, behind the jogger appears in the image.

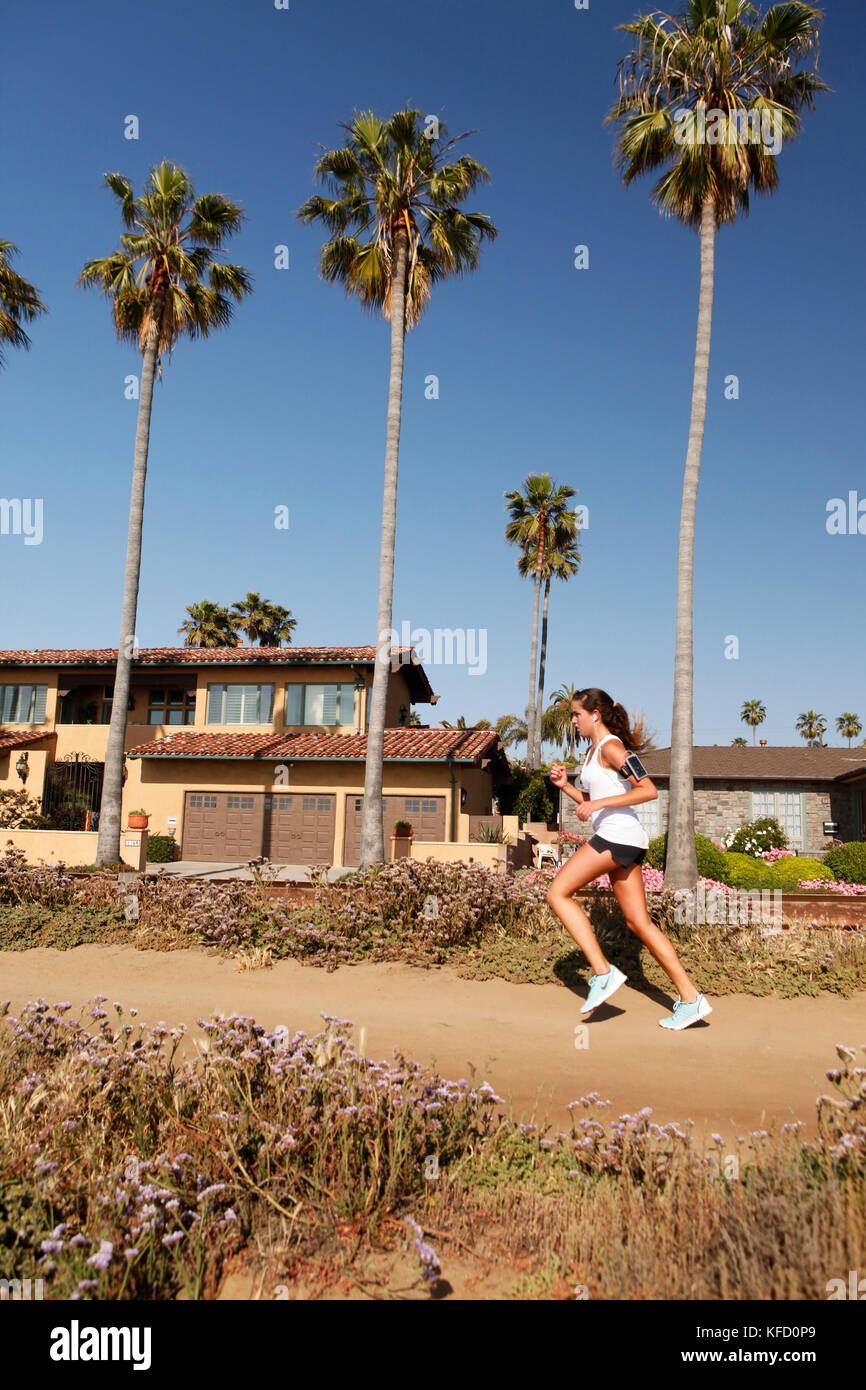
[563,744,866,855]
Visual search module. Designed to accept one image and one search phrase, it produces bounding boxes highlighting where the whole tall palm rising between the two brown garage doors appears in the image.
[297,106,498,867]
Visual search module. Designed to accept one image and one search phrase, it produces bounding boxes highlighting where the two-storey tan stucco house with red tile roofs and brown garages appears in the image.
[0,646,510,866]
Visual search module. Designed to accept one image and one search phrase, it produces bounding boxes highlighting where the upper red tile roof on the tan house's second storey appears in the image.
[0,646,418,666]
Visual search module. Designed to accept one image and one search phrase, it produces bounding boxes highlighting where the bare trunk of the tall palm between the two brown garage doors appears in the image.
[360,228,407,869]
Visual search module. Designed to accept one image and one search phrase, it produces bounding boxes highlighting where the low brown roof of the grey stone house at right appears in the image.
[639,744,866,783]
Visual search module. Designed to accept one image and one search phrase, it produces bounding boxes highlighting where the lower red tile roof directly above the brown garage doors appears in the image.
[126,727,505,763]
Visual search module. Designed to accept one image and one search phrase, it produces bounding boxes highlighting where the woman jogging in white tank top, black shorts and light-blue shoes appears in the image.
[548,688,713,1029]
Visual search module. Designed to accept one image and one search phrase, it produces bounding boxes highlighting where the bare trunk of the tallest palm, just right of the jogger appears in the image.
[662,199,716,888]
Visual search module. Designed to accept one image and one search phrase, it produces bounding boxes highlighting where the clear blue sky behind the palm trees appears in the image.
[0,0,866,746]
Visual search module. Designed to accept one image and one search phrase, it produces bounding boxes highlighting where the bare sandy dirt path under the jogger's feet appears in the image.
[0,945,866,1154]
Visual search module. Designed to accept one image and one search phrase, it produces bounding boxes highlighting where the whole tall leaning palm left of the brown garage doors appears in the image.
[78,160,252,863]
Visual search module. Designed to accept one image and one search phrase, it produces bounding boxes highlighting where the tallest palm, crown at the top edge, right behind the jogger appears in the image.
[607,0,828,888]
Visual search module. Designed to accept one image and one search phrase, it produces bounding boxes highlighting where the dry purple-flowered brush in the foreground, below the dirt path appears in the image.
[0,995,866,1301]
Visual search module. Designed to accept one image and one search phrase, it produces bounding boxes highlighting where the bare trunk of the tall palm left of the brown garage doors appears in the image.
[96,303,161,865]
